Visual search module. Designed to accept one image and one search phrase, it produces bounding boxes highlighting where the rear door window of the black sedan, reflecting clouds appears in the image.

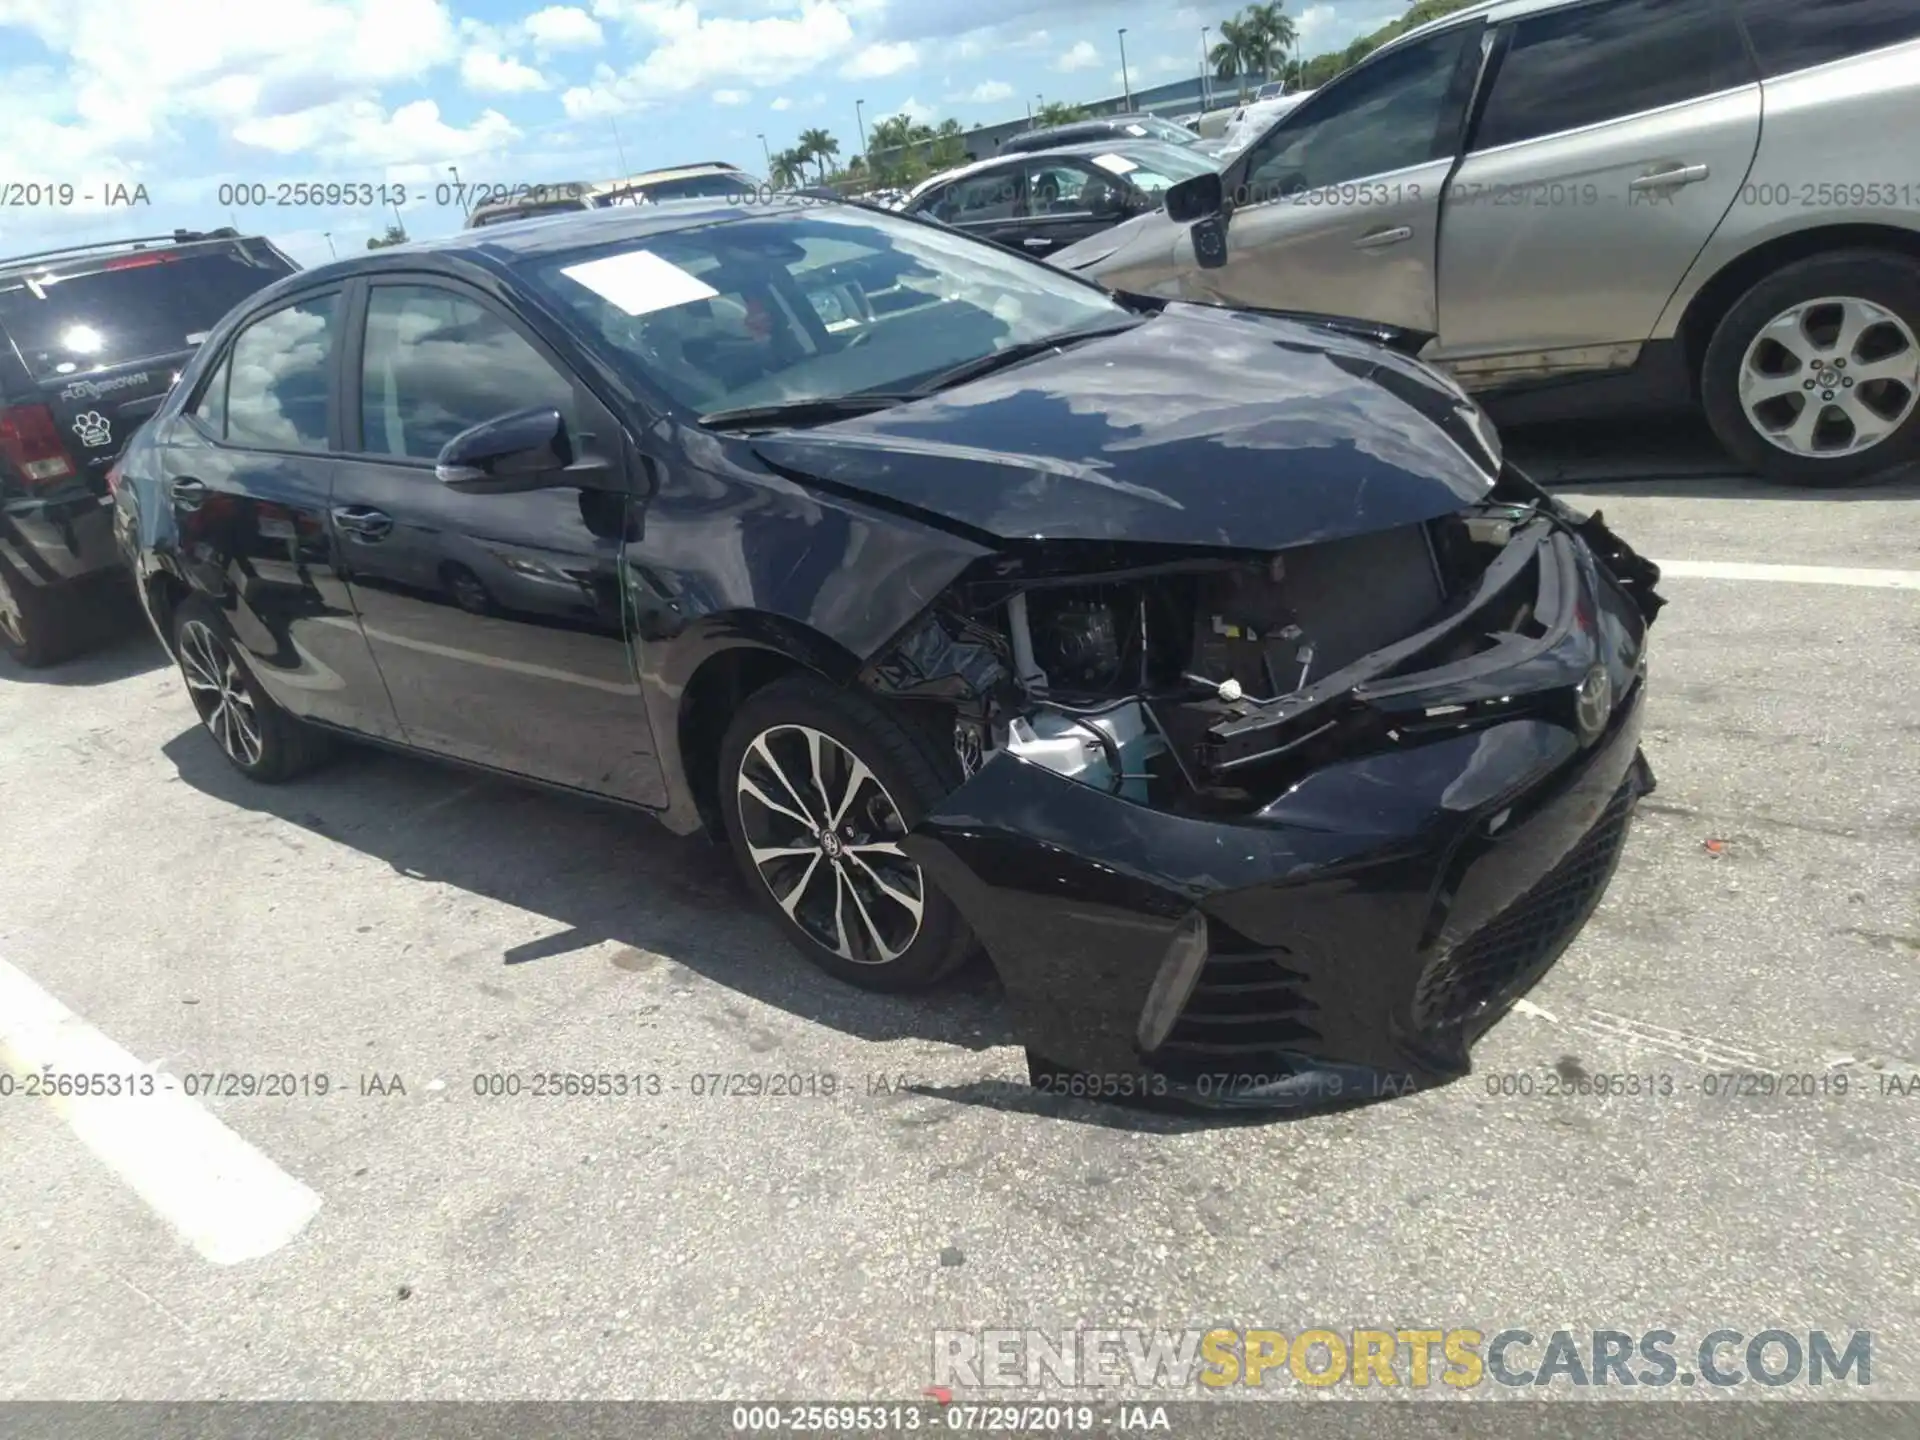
[215,294,340,449]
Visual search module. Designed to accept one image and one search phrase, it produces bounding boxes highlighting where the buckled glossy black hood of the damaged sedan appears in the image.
[753,303,1498,549]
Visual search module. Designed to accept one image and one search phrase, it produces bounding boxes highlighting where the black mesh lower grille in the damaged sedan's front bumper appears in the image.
[1413,780,1636,1029]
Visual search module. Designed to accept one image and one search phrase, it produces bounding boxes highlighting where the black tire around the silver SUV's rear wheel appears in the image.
[1699,250,1920,486]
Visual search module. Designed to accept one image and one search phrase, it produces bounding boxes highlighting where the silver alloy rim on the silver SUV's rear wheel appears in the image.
[1740,296,1920,459]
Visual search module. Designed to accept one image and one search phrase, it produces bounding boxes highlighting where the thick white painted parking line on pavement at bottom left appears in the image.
[0,960,321,1265]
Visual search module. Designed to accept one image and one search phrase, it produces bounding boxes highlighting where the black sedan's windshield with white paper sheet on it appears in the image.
[528,207,1131,415]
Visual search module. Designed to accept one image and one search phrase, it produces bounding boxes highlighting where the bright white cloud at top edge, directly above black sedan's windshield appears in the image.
[556,0,852,119]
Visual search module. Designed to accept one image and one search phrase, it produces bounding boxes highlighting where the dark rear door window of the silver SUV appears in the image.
[1473,0,1758,150]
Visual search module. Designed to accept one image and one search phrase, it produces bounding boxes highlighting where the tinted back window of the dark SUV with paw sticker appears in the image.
[0,244,294,380]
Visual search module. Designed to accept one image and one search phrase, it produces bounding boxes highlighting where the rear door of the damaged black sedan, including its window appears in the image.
[156,286,399,739]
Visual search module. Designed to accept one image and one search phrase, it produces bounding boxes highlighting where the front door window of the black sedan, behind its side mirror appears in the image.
[361,284,574,461]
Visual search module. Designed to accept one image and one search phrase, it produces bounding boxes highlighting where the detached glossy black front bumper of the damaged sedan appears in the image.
[906,503,1653,1106]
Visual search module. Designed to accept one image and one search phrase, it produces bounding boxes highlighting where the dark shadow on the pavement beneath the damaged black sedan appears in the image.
[161,728,1273,1133]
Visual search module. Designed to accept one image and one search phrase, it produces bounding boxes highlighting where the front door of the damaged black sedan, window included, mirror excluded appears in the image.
[330,278,664,804]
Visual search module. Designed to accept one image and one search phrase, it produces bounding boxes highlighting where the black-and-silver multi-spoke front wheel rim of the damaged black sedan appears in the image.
[735,726,927,966]
